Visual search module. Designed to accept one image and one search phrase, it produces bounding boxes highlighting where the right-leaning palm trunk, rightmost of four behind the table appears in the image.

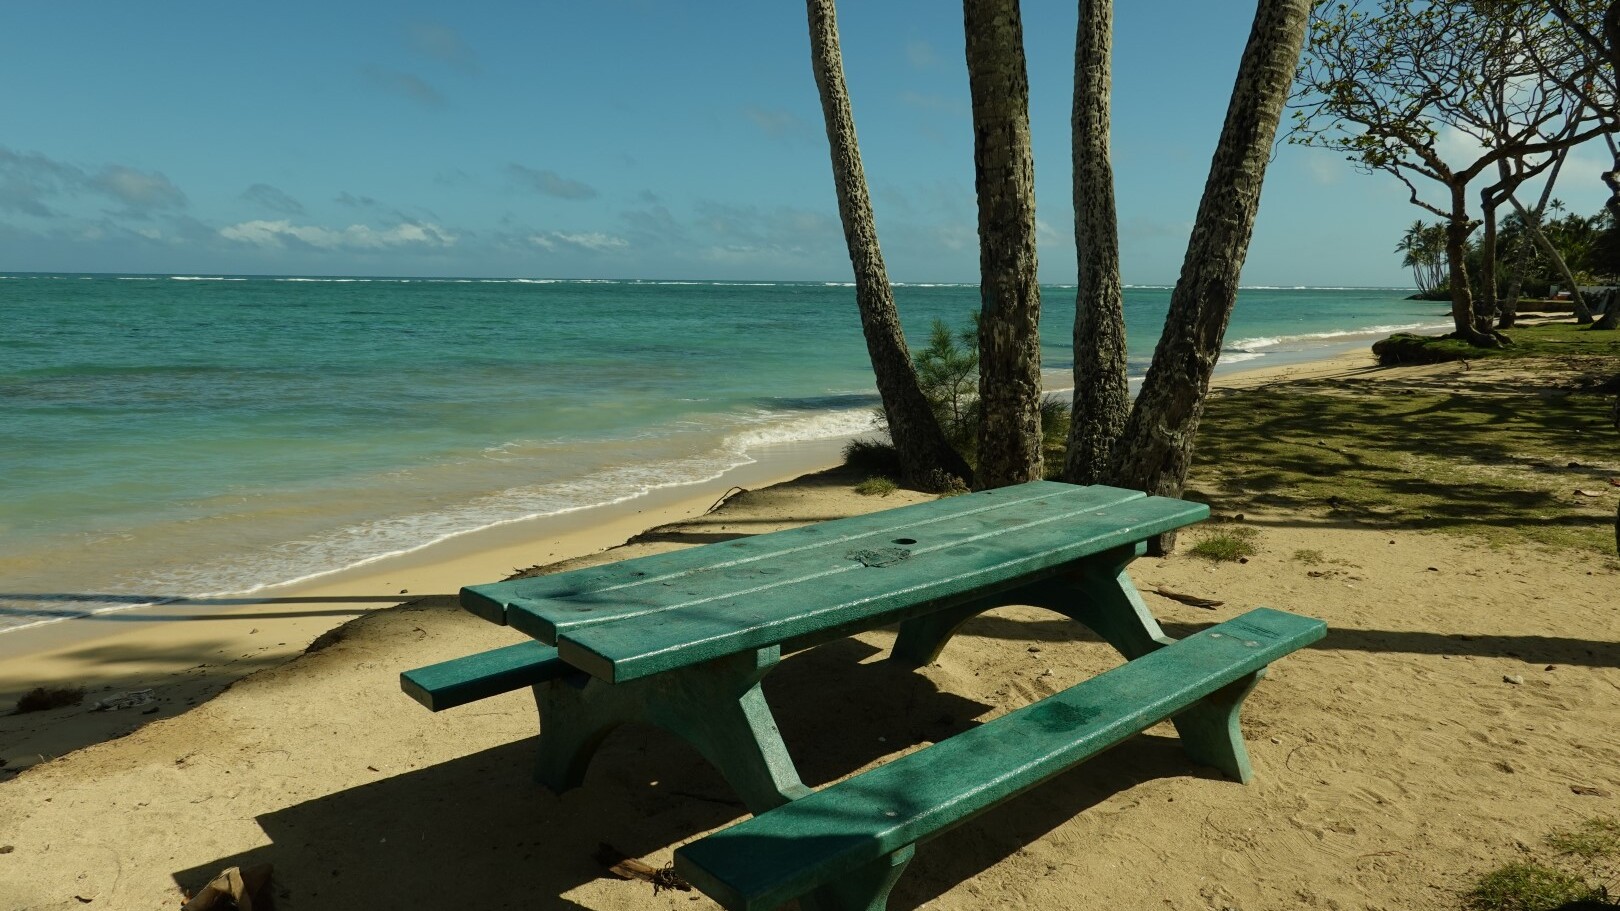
[1113,0,1312,538]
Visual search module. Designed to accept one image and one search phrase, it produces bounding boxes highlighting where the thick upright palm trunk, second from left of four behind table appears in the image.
[962,0,1042,490]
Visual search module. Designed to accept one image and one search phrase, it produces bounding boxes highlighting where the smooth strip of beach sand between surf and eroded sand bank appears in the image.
[0,342,1374,770]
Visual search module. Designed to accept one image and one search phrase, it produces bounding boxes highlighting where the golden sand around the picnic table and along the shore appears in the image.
[0,348,1620,909]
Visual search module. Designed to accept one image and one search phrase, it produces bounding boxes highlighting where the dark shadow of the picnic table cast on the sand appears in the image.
[173,640,1213,909]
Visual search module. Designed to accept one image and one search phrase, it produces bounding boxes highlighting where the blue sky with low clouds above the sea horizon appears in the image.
[0,0,1604,287]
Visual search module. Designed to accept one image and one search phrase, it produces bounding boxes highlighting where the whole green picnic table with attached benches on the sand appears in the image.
[400,481,1324,909]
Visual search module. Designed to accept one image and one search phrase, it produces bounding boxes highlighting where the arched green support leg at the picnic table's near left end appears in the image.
[535,647,810,814]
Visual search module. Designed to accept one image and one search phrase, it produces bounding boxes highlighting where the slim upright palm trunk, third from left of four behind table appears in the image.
[1063,0,1131,485]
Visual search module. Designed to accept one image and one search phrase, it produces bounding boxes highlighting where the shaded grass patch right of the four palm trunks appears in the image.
[1189,326,1620,559]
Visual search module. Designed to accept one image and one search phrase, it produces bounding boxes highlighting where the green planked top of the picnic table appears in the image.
[462,481,1209,682]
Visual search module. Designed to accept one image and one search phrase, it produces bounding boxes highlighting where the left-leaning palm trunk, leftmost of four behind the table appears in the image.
[805,0,970,490]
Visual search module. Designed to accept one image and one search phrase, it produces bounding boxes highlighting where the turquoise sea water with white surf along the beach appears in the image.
[0,274,1445,629]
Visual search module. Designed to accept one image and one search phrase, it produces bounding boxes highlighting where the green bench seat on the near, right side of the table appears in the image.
[676,608,1325,911]
